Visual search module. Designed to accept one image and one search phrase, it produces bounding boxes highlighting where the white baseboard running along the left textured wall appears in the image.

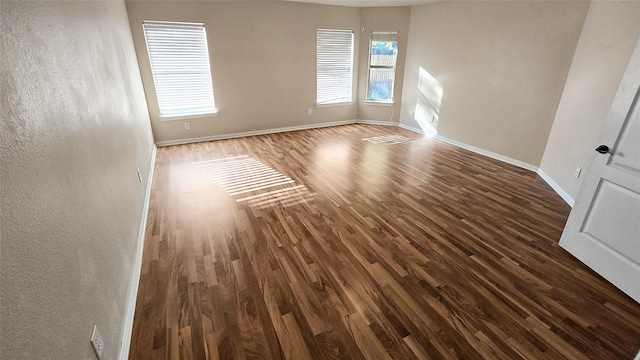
[118,145,158,360]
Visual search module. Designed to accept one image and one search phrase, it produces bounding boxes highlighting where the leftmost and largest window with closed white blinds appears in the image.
[142,21,217,118]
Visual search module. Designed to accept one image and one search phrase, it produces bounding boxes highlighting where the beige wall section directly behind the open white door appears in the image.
[540,1,640,199]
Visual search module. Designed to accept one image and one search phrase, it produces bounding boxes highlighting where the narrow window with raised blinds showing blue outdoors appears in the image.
[367,31,398,103]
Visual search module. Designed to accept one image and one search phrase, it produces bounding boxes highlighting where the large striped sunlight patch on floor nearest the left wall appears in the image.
[194,155,315,209]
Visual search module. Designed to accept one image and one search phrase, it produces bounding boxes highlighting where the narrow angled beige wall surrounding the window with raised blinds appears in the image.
[357,7,411,123]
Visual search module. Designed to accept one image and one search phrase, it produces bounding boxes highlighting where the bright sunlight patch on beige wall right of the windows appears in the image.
[414,67,444,136]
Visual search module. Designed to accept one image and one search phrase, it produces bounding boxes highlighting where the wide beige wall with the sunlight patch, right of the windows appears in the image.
[400,1,589,166]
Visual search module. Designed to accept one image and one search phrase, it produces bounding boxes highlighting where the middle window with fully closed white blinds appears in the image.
[316,29,353,105]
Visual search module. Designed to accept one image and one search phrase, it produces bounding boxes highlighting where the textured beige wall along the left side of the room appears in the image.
[0,1,153,360]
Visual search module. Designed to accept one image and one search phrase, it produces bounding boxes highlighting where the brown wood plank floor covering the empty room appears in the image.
[130,125,640,360]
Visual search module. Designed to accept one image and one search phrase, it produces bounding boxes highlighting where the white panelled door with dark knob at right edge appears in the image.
[560,36,640,302]
